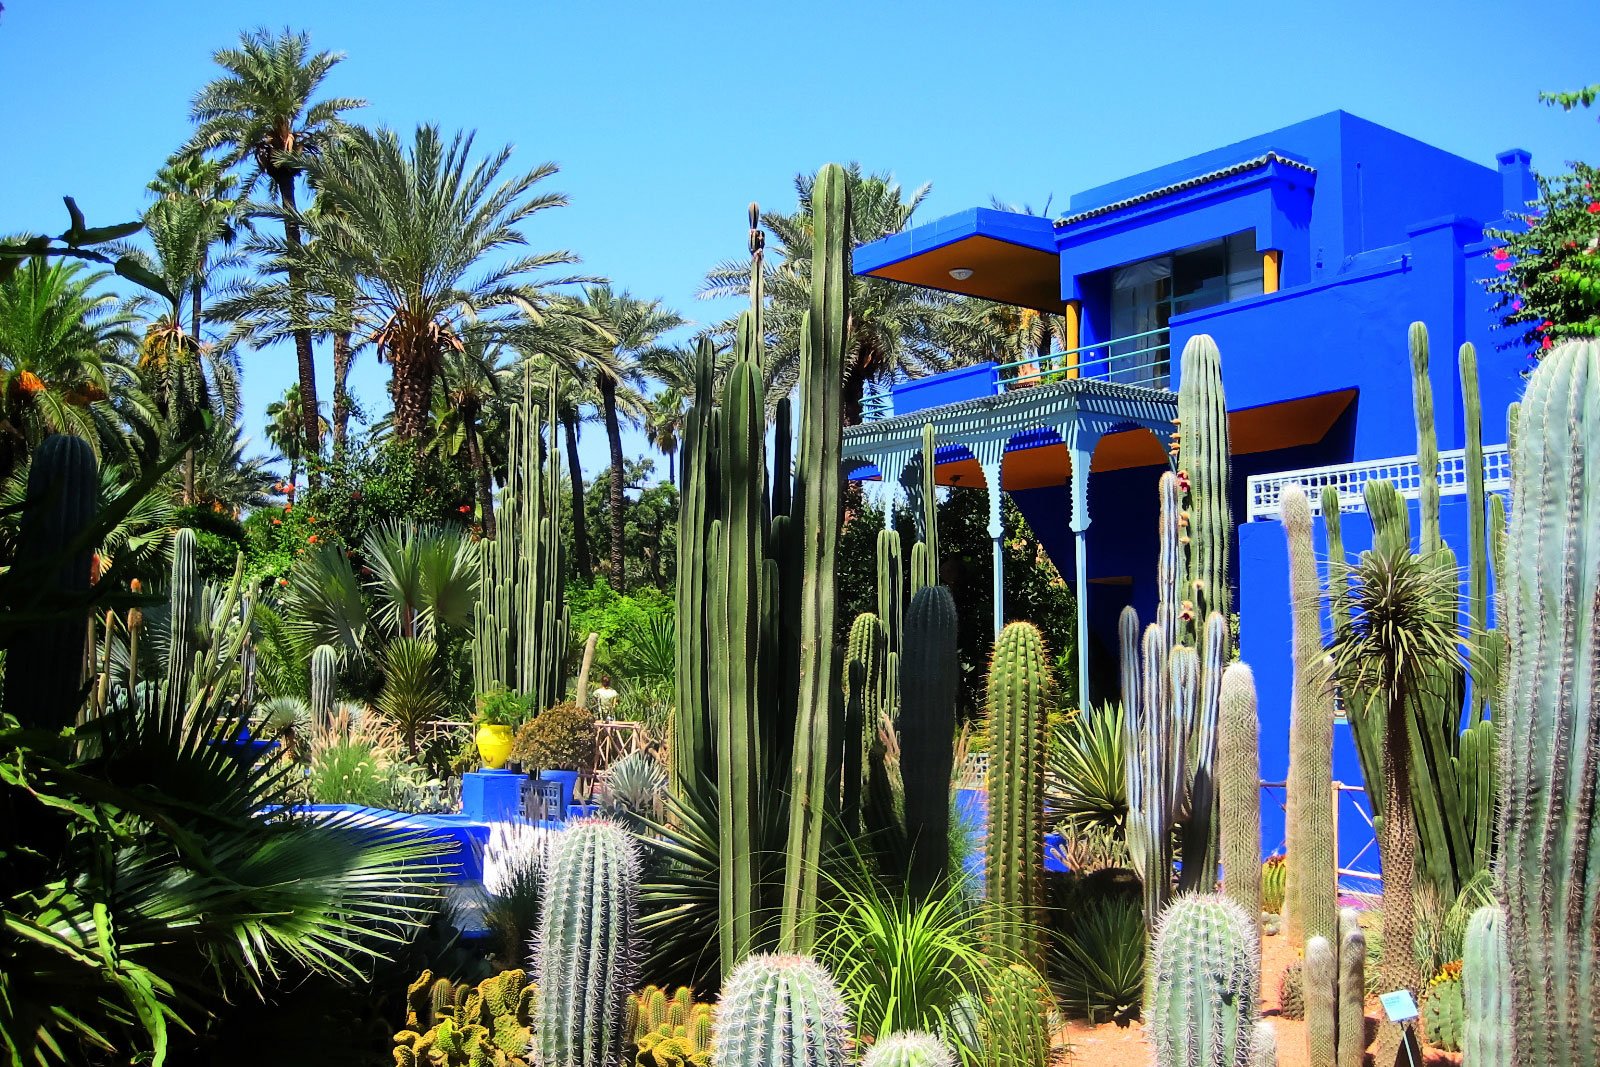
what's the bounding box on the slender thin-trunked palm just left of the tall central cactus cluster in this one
[569,285,685,592]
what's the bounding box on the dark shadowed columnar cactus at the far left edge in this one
[5,434,99,733]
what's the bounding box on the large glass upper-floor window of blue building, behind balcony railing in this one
[1090,230,1262,389]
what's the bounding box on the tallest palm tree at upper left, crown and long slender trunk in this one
[186,30,366,456]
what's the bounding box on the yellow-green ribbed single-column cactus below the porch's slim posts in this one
[984,622,1050,969]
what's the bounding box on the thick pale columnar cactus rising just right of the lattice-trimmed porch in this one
[1178,334,1234,640]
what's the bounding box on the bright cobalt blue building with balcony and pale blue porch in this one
[845,112,1536,877]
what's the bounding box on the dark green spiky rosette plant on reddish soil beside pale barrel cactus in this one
[1051,894,1144,1024]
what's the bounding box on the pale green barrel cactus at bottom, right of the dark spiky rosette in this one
[1149,894,1261,1067]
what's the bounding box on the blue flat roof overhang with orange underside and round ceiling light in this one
[854,208,1062,312]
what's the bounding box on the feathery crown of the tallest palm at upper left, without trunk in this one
[187,29,366,192]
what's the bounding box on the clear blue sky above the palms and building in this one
[0,0,1600,474]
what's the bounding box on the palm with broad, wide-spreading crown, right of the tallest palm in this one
[285,126,579,440]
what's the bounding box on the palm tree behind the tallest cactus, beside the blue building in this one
[701,163,978,426]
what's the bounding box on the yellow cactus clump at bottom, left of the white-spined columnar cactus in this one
[394,971,534,1067]
